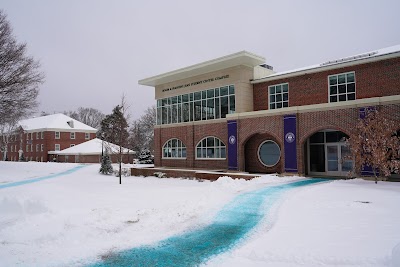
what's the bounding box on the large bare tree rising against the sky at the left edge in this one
[0,10,44,124]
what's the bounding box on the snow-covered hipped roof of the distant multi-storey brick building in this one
[19,113,97,132]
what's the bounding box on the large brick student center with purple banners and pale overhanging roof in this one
[139,46,400,176]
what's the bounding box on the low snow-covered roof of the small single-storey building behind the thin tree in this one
[49,138,136,155]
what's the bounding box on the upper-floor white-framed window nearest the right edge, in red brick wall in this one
[328,71,356,103]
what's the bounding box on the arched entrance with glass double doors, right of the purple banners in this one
[307,130,353,176]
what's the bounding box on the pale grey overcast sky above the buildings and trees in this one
[0,0,400,118]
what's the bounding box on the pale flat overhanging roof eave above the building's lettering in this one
[139,51,265,87]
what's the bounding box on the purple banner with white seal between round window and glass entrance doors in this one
[283,114,298,172]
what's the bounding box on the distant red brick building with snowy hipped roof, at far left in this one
[0,114,97,161]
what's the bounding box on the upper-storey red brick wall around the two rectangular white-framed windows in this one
[253,58,400,111]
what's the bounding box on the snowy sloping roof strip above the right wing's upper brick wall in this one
[253,45,400,83]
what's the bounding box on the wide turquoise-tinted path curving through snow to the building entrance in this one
[84,179,327,267]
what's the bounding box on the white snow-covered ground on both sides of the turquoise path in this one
[0,162,400,266]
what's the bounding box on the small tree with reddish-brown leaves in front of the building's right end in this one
[348,109,400,183]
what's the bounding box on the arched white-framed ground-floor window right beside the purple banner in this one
[196,136,226,159]
